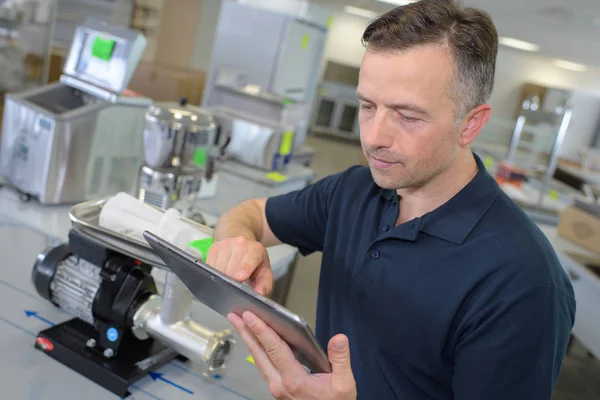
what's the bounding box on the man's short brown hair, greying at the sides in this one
[362,0,498,121]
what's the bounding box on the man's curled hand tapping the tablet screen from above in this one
[206,236,273,295]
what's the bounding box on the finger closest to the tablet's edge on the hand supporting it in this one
[242,311,307,382]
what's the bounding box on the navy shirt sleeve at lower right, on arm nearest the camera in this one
[453,282,575,400]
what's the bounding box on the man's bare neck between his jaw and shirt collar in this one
[396,150,478,225]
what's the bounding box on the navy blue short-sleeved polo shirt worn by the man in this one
[266,152,575,400]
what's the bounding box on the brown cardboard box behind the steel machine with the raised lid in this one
[129,62,206,105]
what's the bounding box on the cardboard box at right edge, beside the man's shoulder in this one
[558,206,600,254]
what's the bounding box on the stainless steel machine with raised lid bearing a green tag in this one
[0,20,152,204]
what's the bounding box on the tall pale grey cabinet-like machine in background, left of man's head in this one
[202,0,331,156]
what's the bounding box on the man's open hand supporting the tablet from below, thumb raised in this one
[227,311,356,400]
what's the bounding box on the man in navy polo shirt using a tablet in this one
[207,0,575,400]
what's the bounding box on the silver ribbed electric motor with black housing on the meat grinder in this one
[32,232,157,356]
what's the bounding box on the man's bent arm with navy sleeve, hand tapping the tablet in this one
[206,168,343,294]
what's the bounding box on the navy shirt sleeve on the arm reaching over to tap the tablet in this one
[265,167,348,255]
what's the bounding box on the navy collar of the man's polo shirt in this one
[381,154,501,244]
